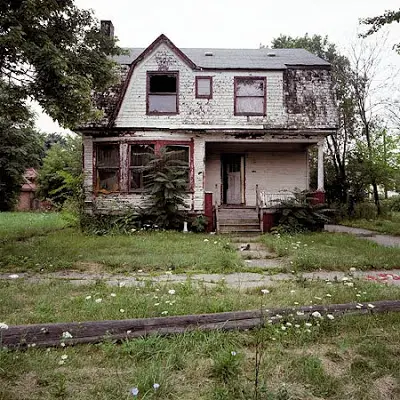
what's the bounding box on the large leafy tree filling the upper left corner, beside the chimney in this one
[0,0,121,128]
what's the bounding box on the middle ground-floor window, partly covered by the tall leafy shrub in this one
[129,144,154,191]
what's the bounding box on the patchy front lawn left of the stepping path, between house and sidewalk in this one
[0,228,243,272]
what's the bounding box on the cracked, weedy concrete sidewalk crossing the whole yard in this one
[0,269,400,289]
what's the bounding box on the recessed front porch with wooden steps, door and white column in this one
[204,142,324,233]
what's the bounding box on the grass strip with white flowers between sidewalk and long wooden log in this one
[0,280,400,325]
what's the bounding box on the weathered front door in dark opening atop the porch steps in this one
[222,154,244,205]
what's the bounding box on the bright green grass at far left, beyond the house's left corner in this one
[0,212,70,244]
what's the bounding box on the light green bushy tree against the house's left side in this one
[38,135,82,206]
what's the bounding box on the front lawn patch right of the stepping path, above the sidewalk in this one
[262,232,400,271]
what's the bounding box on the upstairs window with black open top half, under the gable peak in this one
[147,72,179,115]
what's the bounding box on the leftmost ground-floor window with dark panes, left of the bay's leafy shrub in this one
[96,144,119,193]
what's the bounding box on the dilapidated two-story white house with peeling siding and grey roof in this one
[80,21,338,232]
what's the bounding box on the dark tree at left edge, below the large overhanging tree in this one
[0,79,43,211]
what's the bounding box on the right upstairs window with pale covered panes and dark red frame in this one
[234,76,266,115]
